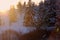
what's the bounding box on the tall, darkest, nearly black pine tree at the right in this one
[44,0,56,27]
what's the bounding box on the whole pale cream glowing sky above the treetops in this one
[0,0,43,11]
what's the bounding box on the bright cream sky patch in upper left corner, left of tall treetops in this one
[0,0,19,12]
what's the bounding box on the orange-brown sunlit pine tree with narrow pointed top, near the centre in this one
[24,0,34,26]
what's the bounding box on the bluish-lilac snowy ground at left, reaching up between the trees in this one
[0,12,35,34]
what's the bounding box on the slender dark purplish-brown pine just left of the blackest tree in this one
[35,1,44,29]
